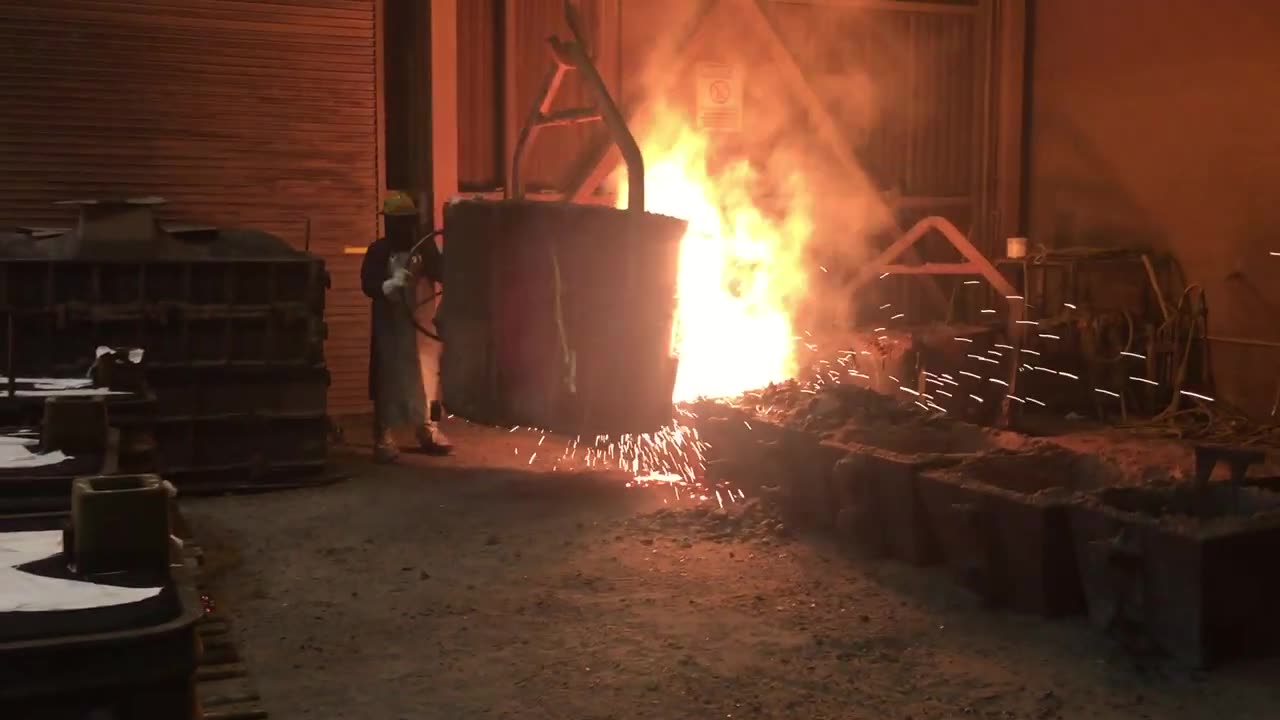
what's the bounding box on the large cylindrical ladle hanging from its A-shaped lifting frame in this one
[439,0,687,438]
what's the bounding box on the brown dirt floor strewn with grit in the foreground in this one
[183,425,1280,720]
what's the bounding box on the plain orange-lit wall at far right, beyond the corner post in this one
[1027,0,1280,415]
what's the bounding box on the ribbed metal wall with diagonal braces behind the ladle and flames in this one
[458,0,992,249]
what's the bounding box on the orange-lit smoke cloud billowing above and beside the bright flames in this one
[614,0,908,334]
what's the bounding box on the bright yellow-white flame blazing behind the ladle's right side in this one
[618,104,813,402]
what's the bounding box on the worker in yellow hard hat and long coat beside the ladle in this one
[360,192,452,462]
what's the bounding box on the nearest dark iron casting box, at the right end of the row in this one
[1071,483,1280,667]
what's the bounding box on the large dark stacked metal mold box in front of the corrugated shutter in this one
[0,200,329,489]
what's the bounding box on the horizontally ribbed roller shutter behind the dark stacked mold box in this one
[0,0,380,414]
